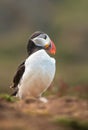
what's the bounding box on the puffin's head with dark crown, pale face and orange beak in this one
[27,31,55,55]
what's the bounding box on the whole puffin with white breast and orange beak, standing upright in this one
[10,31,56,102]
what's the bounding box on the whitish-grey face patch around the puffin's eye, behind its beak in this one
[32,34,51,47]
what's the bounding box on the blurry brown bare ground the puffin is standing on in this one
[0,96,88,130]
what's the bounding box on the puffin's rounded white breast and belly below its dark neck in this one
[18,49,55,98]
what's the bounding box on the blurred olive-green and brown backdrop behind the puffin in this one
[0,0,88,93]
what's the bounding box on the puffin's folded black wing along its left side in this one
[11,62,25,88]
